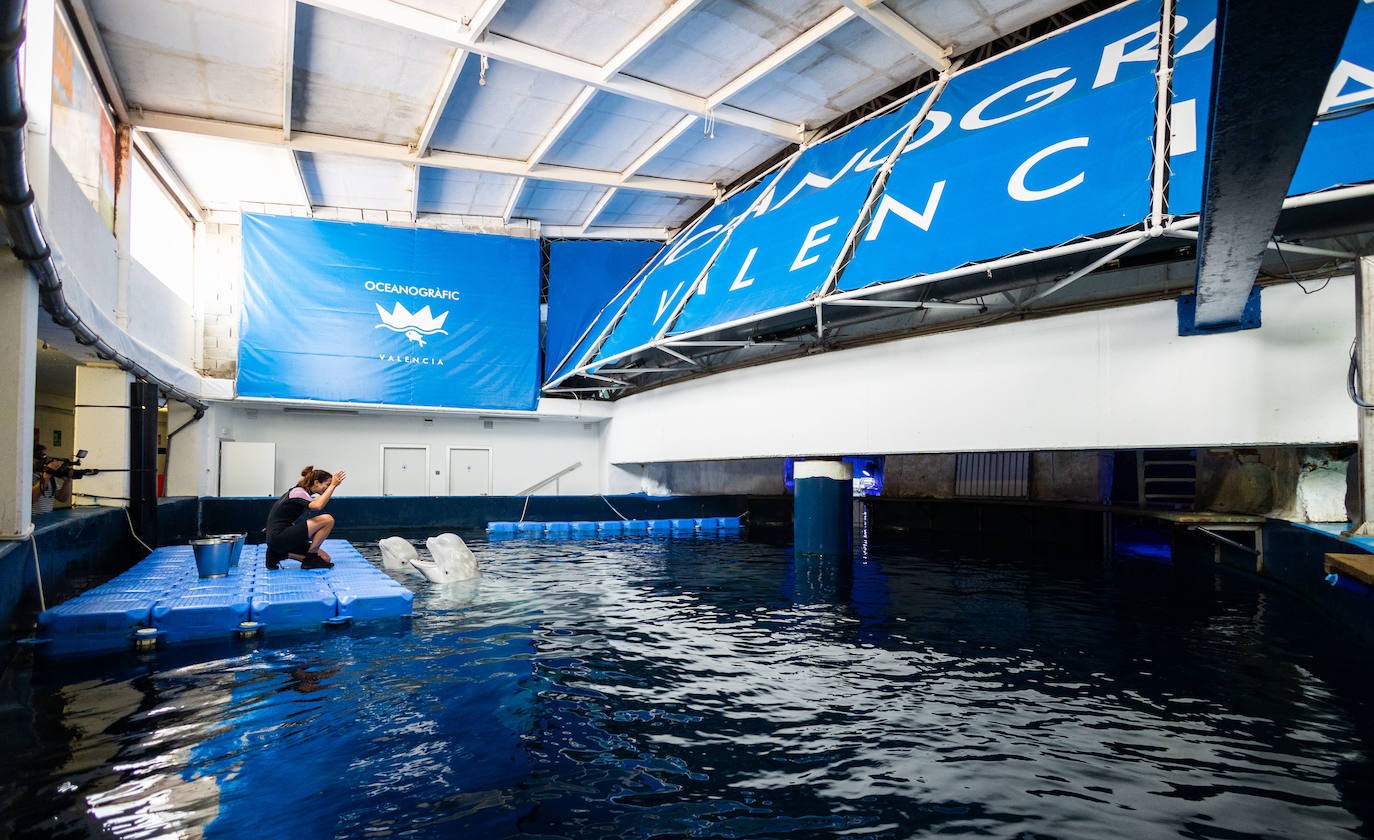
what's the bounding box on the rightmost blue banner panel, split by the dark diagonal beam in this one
[1169,0,1374,216]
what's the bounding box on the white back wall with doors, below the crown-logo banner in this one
[200,404,602,496]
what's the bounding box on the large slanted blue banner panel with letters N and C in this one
[840,0,1160,290]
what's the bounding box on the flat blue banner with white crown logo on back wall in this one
[238,214,539,410]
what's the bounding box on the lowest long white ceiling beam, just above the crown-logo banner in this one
[131,111,716,198]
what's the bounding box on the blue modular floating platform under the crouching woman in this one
[38,540,415,652]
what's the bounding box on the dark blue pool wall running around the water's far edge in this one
[8,495,1374,643]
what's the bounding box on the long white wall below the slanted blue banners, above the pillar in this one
[606,276,1356,464]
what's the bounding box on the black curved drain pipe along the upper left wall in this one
[0,0,206,419]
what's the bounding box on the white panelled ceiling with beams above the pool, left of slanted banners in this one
[73,0,1074,238]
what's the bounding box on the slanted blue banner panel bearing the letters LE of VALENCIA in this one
[672,92,929,333]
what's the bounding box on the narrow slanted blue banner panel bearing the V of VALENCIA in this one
[596,179,771,359]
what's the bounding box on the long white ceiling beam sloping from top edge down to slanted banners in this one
[301,0,801,143]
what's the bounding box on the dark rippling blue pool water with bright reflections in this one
[0,533,1374,840]
